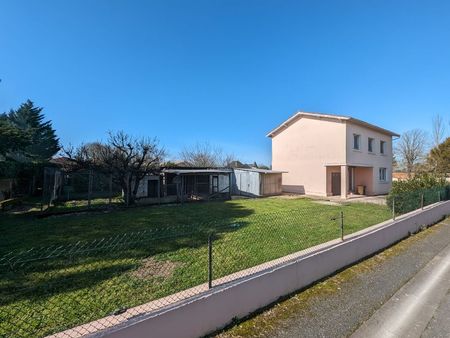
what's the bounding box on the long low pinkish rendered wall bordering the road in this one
[97,201,450,338]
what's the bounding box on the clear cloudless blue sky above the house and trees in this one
[0,0,450,164]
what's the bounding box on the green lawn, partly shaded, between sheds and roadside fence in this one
[0,198,390,337]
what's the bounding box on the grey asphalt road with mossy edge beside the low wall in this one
[219,219,450,338]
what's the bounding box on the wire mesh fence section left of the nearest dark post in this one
[0,227,212,337]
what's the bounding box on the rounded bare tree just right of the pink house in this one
[396,129,427,176]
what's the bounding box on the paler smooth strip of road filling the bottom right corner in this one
[352,240,450,338]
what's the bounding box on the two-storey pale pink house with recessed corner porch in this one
[267,112,399,198]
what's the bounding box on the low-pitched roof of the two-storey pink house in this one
[267,112,400,137]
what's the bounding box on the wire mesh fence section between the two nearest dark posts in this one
[209,209,341,286]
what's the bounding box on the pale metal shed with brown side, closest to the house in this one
[233,168,283,197]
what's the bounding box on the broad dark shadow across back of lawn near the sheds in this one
[0,202,253,252]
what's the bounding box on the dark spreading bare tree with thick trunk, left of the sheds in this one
[64,131,165,204]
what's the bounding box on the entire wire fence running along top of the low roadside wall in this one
[0,193,448,337]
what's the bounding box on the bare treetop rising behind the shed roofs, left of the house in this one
[180,142,235,167]
